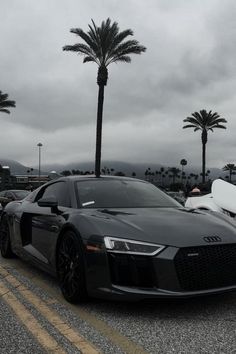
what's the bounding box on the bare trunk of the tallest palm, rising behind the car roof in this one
[95,85,104,177]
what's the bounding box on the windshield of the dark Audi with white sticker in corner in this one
[76,178,181,208]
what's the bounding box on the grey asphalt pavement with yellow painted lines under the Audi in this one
[0,254,236,354]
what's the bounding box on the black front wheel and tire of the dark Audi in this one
[57,231,88,303]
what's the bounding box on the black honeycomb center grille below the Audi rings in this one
[174,244,236,291]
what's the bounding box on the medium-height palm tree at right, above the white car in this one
[183,109,227,183]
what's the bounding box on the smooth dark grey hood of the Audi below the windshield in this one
[86,208,236,247]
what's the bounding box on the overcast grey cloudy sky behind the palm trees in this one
[0,0,236,168]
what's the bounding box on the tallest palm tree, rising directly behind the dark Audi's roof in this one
[63,18,146,177]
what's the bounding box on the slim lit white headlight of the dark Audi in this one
[104,236,165,256]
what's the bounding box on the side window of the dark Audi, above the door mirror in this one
[36,181,70,207]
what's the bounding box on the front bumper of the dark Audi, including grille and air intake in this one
[88,244,236,300]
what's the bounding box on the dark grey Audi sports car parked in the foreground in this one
[0,176,236,302]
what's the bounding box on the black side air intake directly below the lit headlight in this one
[108,253,157,288]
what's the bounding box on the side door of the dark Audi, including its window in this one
[21,181,70,264]
